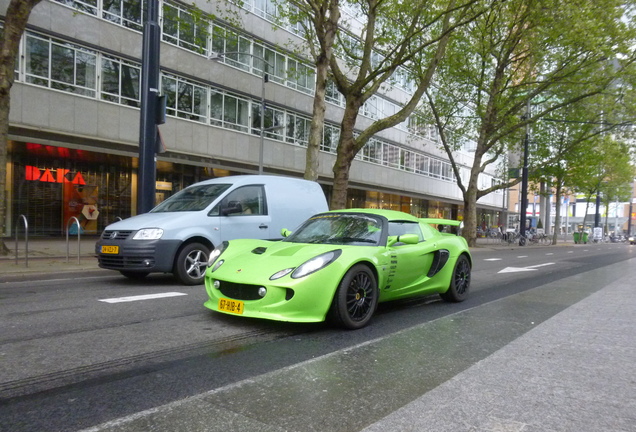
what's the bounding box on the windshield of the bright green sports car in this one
[284,213,382,246]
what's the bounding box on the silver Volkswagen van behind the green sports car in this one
[95,175,328,285]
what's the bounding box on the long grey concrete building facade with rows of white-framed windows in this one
[0,0,507,235]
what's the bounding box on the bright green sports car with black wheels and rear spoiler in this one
[205,209,472,329]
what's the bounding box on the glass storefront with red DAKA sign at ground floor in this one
[8,142,221,235]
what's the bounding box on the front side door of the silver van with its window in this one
[213,185,271,240]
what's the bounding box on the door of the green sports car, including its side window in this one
[389,221,433,296]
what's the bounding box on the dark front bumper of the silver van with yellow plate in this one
[95,239,181,273]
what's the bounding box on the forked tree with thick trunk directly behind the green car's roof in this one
[330,0,490,209]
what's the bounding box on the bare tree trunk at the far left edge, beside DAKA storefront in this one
[0,0,41,255]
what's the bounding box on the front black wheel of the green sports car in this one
[330,264,378,330]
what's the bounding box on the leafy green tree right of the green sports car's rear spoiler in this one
[427,0,635,246]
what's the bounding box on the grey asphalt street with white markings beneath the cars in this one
[0,238,636,431]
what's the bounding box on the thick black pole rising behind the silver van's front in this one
[137,0,161,214]
